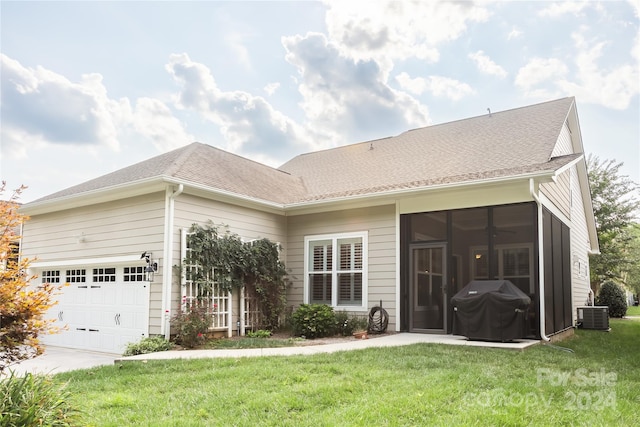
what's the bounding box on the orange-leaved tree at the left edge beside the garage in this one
[0,182,61,372]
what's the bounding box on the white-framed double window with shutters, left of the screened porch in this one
[304,232,367,308]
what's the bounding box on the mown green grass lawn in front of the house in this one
[55,320,640,426]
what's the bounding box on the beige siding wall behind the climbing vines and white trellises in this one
[171,194,286,331]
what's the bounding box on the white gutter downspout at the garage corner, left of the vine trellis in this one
[160,184,184,339]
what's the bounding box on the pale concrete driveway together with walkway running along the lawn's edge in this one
[10,333,539,375]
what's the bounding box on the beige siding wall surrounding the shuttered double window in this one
[286,205,396,330]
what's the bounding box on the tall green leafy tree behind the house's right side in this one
[587,155,639,289]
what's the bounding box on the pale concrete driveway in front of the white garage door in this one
[9,346,121,375]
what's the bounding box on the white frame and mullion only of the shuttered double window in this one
[303,231,369,311]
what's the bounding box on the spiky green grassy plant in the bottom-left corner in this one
[0,371,80,427]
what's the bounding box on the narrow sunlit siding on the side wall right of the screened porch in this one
[570,167,591,321]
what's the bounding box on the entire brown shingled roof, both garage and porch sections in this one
[28,98,580,211]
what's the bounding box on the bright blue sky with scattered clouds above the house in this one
[0,0,640,202]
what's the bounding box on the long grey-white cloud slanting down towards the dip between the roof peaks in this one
[166,54,306,165]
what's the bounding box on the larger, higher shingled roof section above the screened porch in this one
[280,98,579,200]
